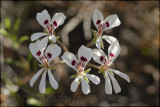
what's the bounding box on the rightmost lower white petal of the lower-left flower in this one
[48,69,58,89]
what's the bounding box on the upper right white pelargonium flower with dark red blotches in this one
[93,9,121,49]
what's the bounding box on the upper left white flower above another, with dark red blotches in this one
[31,10,66,44]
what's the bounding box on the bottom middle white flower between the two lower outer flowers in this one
[61,45,100,94]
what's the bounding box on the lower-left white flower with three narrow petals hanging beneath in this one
[29,40,61,93]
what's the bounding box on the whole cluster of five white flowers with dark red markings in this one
[29,9,130,94]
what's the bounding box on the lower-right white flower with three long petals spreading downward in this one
[93,39,130,94]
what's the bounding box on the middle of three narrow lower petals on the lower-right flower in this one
[108,72,121,93]
